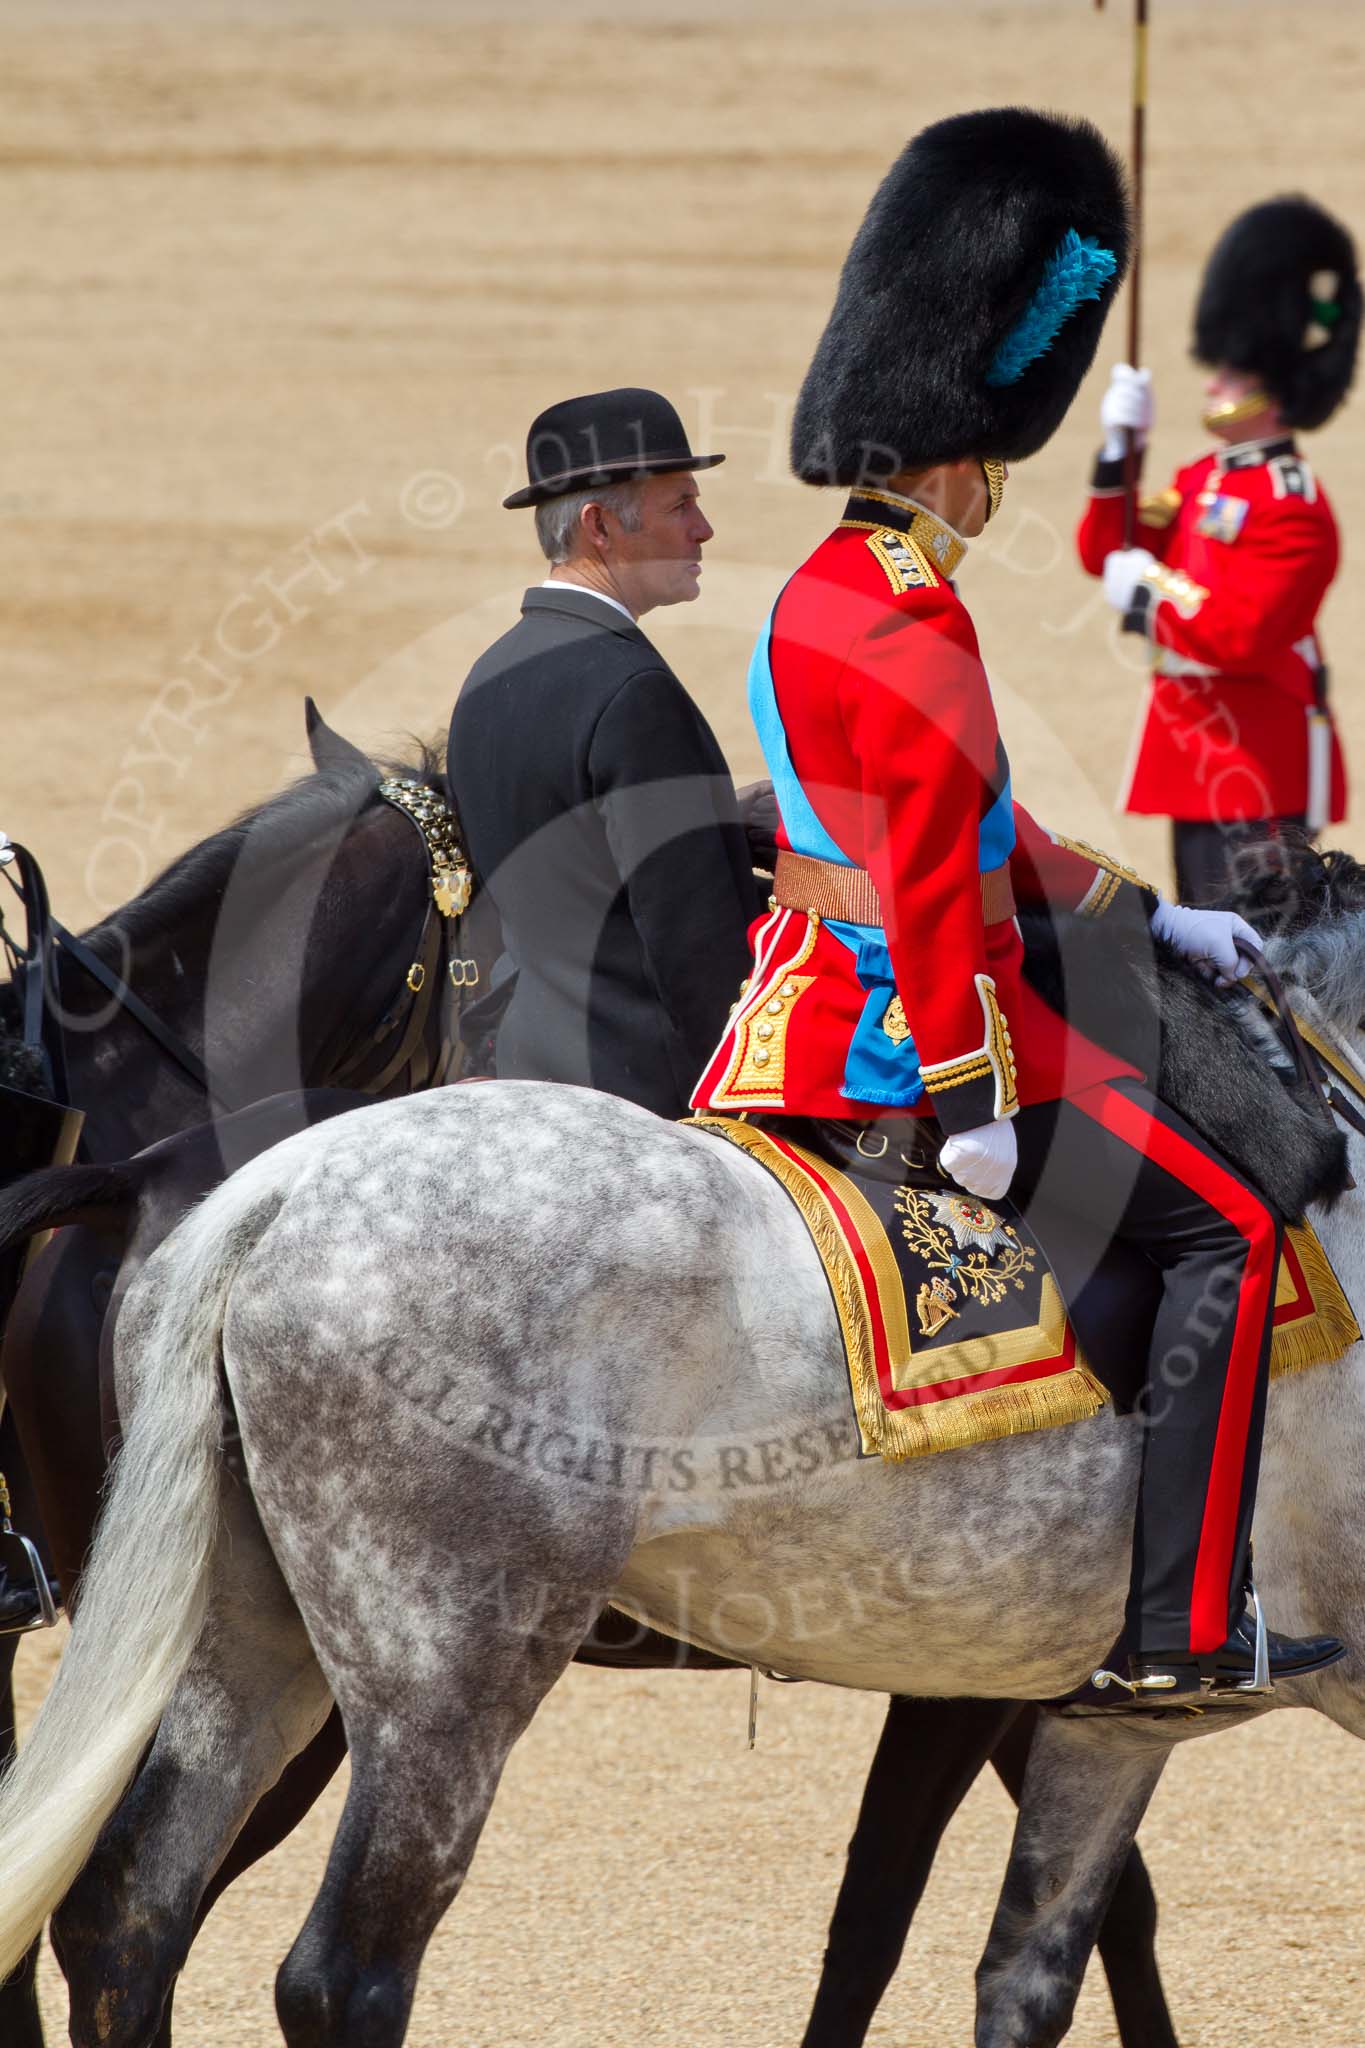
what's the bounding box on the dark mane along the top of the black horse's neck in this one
[0,739,446,1092]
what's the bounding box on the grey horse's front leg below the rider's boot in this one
[976,1714,1177,2048]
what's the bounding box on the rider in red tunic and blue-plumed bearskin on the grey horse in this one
[694,109,1340,1702]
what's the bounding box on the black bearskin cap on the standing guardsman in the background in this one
[1195,197,1361,426]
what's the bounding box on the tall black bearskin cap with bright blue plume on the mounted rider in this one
[792,106,1132,485]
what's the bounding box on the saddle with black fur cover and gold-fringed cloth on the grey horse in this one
[694,926,1361,1460]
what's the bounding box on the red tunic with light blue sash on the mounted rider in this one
[694,492,1140,1130]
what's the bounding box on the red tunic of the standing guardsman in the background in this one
[1076,436,1347,825]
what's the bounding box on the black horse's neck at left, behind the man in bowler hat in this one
[14,762,448,1159]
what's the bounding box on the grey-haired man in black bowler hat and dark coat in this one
[448,389,757,1116]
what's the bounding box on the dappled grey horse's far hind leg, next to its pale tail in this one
[53,1483,329,2048]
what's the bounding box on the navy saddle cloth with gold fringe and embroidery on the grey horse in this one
[694,1116,1361,1462]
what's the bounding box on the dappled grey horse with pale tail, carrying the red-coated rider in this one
[0,915,1365,2048]
